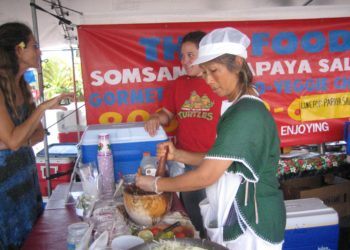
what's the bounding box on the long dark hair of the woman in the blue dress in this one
[0,22,34,118]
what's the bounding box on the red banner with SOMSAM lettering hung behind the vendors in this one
[78,18,350,146]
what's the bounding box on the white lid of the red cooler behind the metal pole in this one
[36,143,78,158]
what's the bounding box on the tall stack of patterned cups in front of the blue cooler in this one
[97,133,115,195]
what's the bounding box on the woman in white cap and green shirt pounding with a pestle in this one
[136,27,286,250]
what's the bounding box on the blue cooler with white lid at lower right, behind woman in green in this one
[283,198,339,250]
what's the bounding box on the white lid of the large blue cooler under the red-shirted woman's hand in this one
[81,122,168,145]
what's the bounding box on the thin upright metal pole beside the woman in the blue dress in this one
[30,0,51,197]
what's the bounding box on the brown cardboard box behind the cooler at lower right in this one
[281,176,350,217]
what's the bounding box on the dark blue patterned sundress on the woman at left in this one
[0,105,43,250]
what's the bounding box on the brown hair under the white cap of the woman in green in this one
[211,54,254,96]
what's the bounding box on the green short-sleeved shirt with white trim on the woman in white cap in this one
[205,95,286,243]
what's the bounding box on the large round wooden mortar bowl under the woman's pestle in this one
[124,189,172,226]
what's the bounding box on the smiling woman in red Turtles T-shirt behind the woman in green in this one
[145,31,223,236]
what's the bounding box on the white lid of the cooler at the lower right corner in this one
[284,198,338,230]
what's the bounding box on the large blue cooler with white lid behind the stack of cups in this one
[80,122,168,181]
